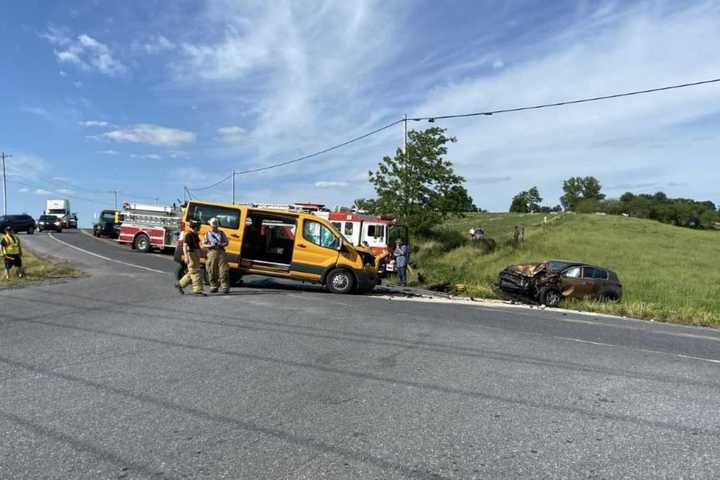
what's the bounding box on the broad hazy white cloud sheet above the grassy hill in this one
[415,2,720,210]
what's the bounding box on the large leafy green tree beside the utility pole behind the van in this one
[368,127,474,233]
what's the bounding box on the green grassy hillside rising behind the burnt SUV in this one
[414,213,720,326]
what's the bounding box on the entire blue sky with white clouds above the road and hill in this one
[0,0,720,225]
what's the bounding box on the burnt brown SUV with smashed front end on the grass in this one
[496,260,622,307]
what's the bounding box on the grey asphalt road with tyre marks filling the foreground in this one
[0,232,720,479]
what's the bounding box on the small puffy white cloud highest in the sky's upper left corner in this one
[43,27,127,76]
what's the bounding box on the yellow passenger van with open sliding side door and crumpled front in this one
[175,200,378,293]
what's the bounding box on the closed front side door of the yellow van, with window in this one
[290,216,342,281]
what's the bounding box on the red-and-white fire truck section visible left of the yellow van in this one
[117,202,182,253]
